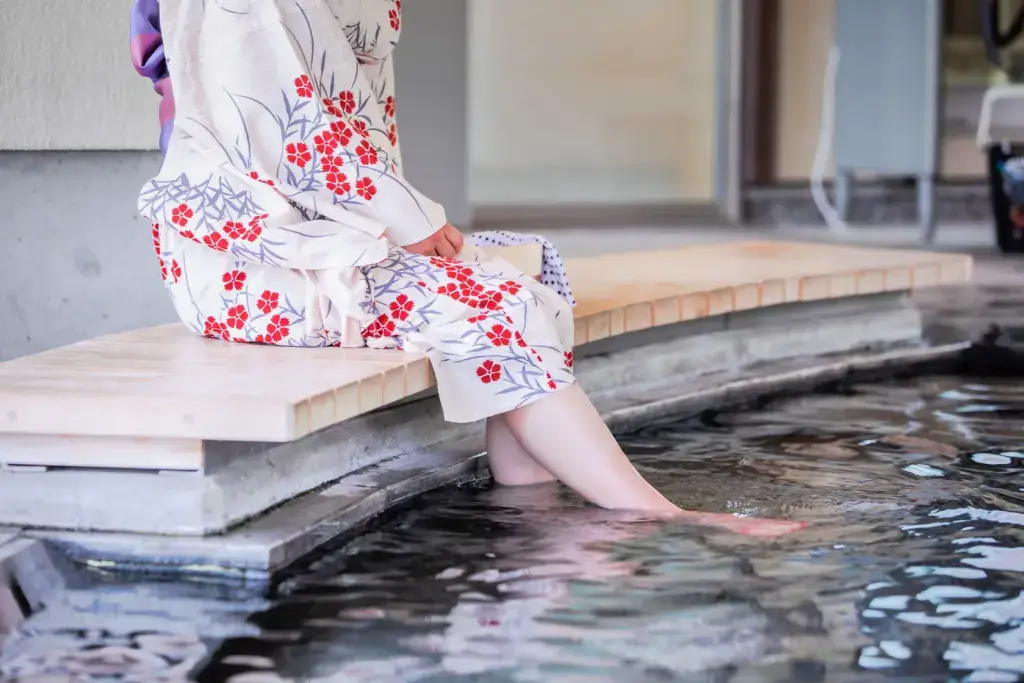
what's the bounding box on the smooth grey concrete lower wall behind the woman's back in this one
[0,152,174,360]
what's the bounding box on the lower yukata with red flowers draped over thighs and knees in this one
[364,250,574,417]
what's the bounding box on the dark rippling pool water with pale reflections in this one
[0,378,1024,683]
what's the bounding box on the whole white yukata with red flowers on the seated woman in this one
[131,0,574,422]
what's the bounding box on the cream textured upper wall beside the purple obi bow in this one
[0,0,160,150]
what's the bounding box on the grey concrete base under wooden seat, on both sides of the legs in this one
[0,294,921,536]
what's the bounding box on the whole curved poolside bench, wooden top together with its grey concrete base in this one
[0,237,971,577]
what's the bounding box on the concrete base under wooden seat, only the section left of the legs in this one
[0,399,482,536]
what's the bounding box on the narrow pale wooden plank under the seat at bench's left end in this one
[0,434,204,471]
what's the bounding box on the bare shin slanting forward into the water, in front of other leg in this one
[504,385,680,513]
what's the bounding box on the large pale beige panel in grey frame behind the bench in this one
[470,0,717,203]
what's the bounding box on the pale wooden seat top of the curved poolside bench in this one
[0,242,972,471]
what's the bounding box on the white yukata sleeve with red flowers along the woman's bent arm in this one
[175,0,446,246]
